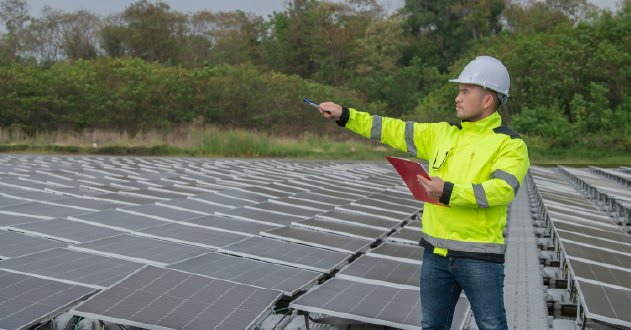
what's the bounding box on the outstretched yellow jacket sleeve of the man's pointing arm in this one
[338,108,435,159]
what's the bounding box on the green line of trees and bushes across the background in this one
[0,0,631,151]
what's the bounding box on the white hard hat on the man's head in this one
[449,56,510,104]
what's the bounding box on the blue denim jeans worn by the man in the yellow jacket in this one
[421,249,508,330]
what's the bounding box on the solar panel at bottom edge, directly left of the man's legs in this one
[289,278,432,330]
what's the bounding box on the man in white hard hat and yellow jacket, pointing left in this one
[320,56,530,330]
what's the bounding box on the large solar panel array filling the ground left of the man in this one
[0,155,440,329]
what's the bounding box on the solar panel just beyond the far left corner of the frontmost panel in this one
[68,234,208,267]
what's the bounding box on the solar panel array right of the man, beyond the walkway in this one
[530,166,631,327]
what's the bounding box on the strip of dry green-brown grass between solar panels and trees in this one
[0,127,631,165]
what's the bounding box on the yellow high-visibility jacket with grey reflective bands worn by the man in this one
[338,108,530,263]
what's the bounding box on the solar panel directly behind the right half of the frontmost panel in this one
[165,252,322,296]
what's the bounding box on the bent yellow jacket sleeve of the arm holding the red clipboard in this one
[440,139,530,208]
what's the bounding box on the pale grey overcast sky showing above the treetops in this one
[21,0,618,17]
